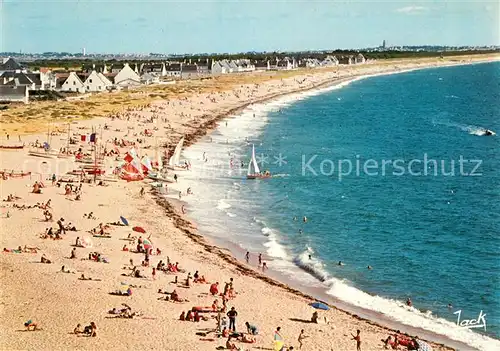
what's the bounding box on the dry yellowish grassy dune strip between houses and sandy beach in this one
[0,55,493,135]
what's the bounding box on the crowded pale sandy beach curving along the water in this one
[0,56,498,350]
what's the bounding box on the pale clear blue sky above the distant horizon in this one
[0,0,500,54]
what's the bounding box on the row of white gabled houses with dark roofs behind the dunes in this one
[0,54,366,101]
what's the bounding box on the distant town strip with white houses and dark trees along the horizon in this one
[0,40,500,104]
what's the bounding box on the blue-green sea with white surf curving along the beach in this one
[183,63,500,350]
